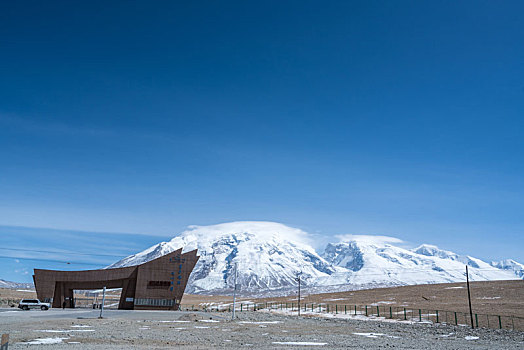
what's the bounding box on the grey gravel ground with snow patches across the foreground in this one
[0,309,524,349]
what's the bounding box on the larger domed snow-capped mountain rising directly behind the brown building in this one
[110,221,337,293]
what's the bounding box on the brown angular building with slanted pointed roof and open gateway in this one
[33,248,199,310]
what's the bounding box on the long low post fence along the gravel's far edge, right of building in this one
[182,303,524,331]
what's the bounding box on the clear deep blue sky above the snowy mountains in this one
[0,1,524,280]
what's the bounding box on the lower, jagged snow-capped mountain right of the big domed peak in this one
[322,236,517,285]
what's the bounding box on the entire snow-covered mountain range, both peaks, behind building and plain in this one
[109,221,524,295]
